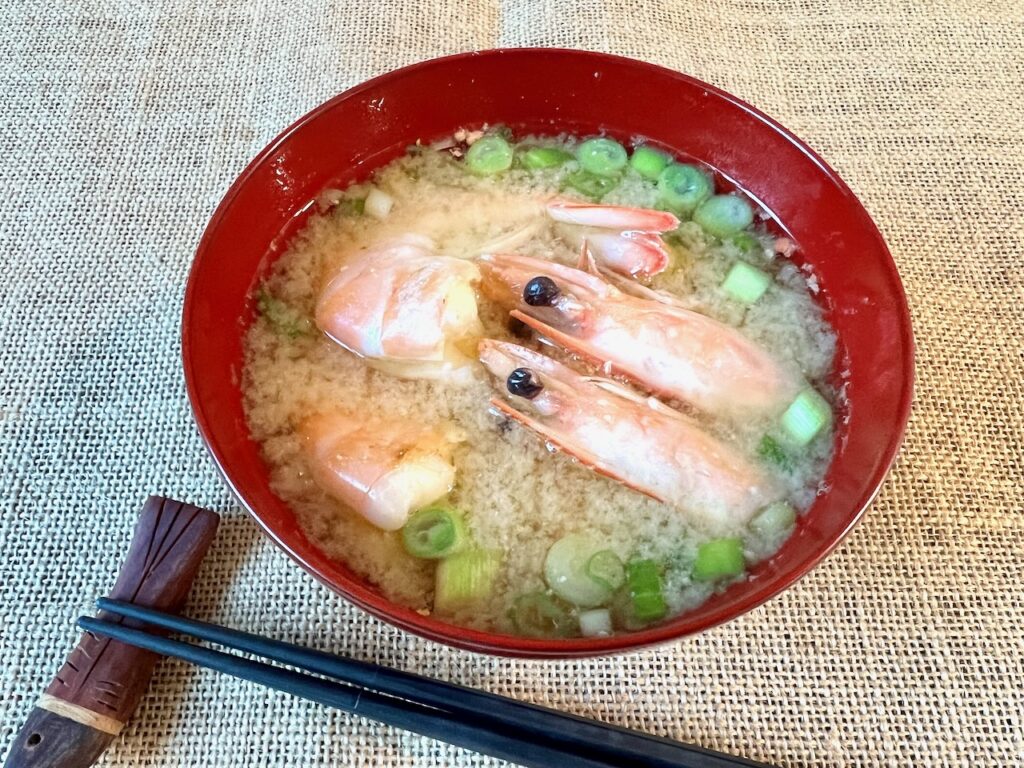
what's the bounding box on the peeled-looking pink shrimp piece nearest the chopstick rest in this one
[299,413,455,530]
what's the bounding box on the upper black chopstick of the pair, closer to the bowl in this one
[97,598,764,768]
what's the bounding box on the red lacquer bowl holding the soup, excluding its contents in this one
[182,49,913,657]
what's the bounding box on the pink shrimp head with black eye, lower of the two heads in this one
[480,339,783,532]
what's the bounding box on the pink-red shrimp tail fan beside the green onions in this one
[547,200,679,278]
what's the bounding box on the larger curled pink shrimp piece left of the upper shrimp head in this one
[315,234,482,383]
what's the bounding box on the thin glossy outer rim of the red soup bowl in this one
[181,47,916,658]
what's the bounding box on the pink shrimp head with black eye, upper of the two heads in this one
[480,254,802,419]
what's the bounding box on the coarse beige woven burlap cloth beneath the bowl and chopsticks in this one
[0,0,1024,768]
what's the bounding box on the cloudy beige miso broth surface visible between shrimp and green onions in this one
[243,139,835,631]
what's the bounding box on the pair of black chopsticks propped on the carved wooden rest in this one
[78,598,765,768]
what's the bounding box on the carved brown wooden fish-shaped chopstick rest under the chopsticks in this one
[4,496,220,768]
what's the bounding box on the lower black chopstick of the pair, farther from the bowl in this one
[78,616,621,768]
